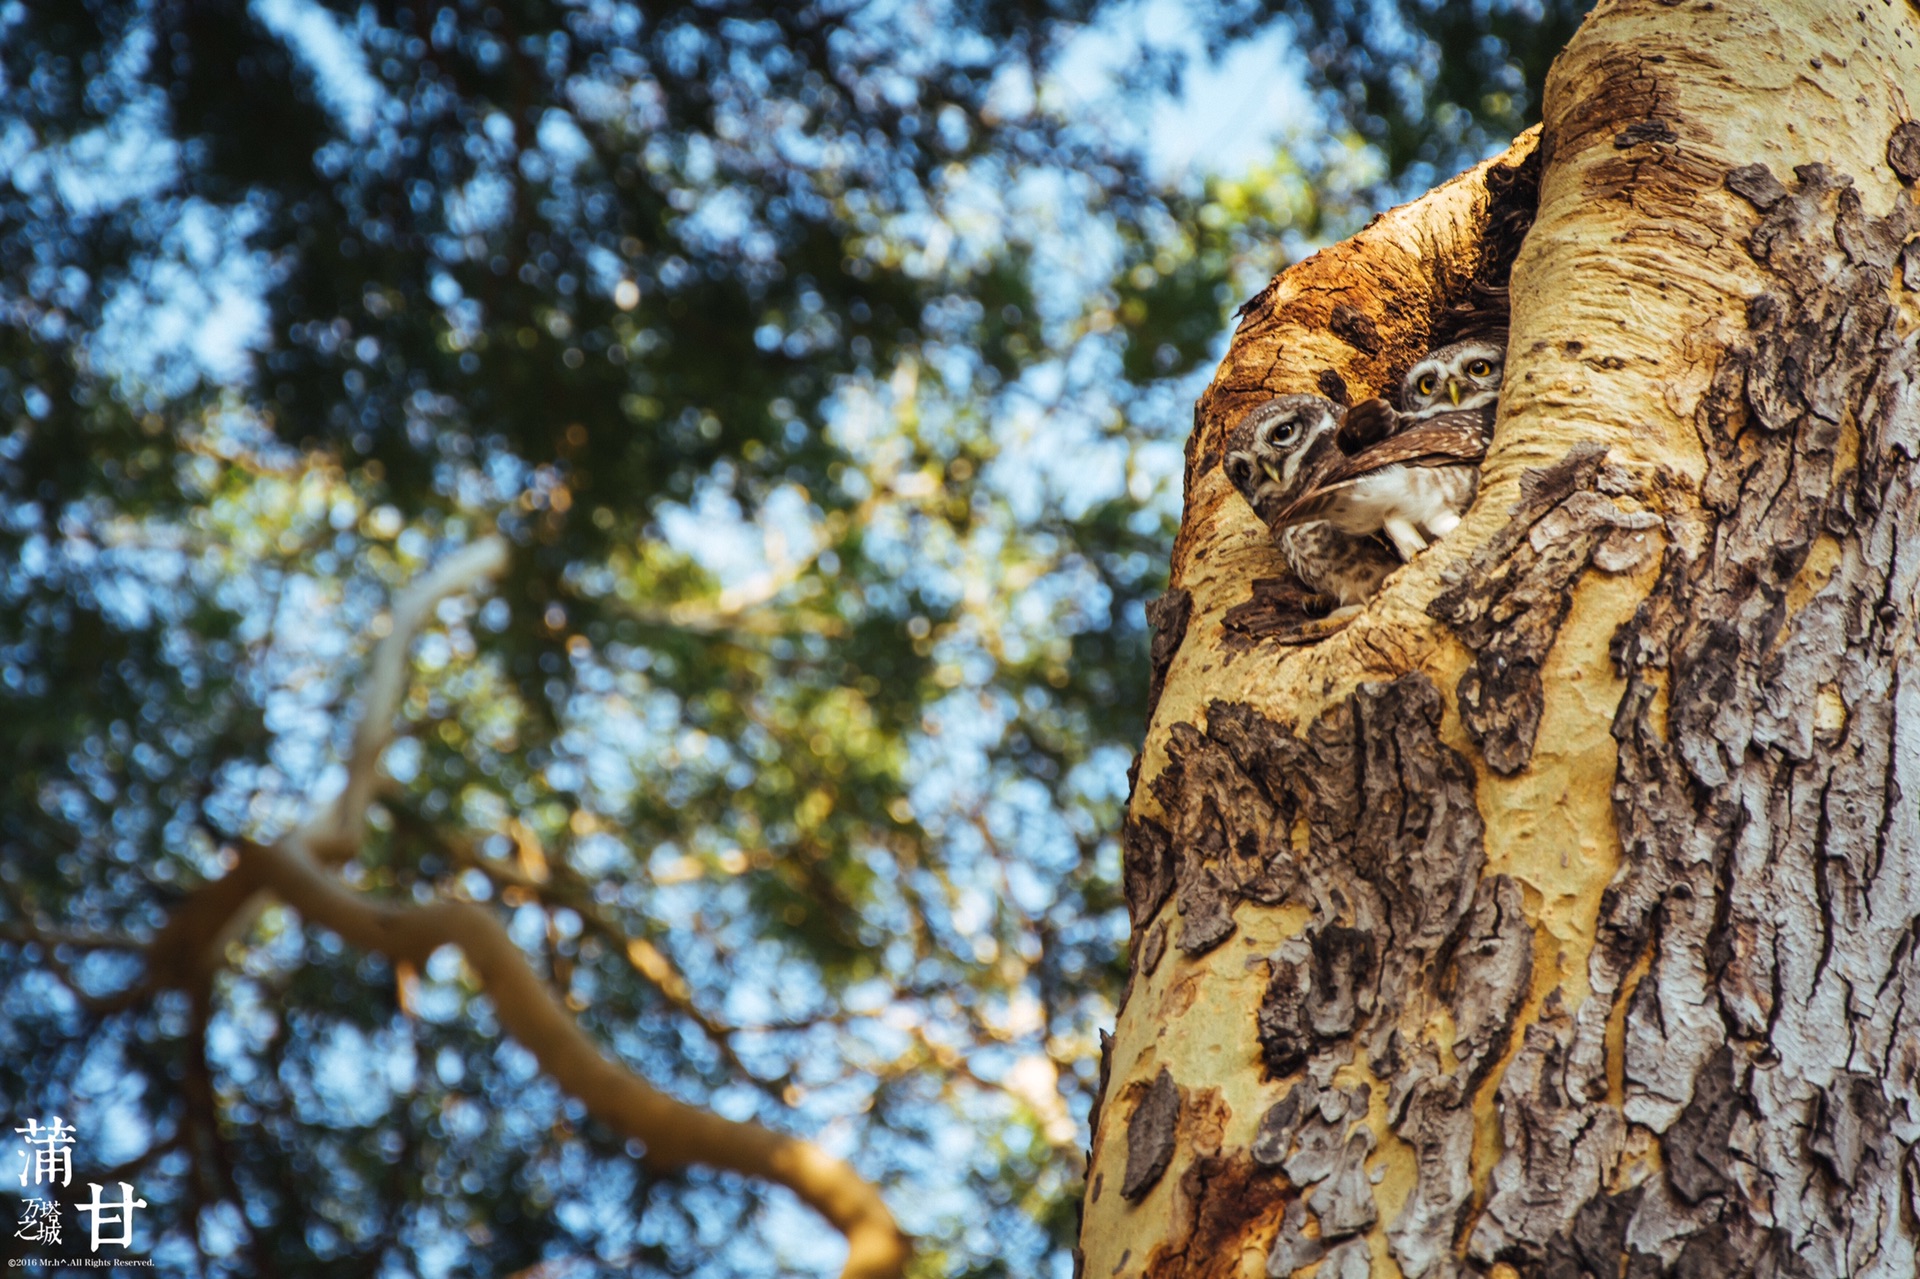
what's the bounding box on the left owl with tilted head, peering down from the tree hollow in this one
[1221,396,1400,618]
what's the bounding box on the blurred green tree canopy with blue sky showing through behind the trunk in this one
[0,0,1584,1275]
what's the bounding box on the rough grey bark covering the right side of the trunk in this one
[1473,156,1920,1279]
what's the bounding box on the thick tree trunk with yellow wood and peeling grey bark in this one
[1081,0,1920,1279]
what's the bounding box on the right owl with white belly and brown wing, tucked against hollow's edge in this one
[1275,342,1505,559]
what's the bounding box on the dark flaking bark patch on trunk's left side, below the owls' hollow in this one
[1121,676,1532,1273]
